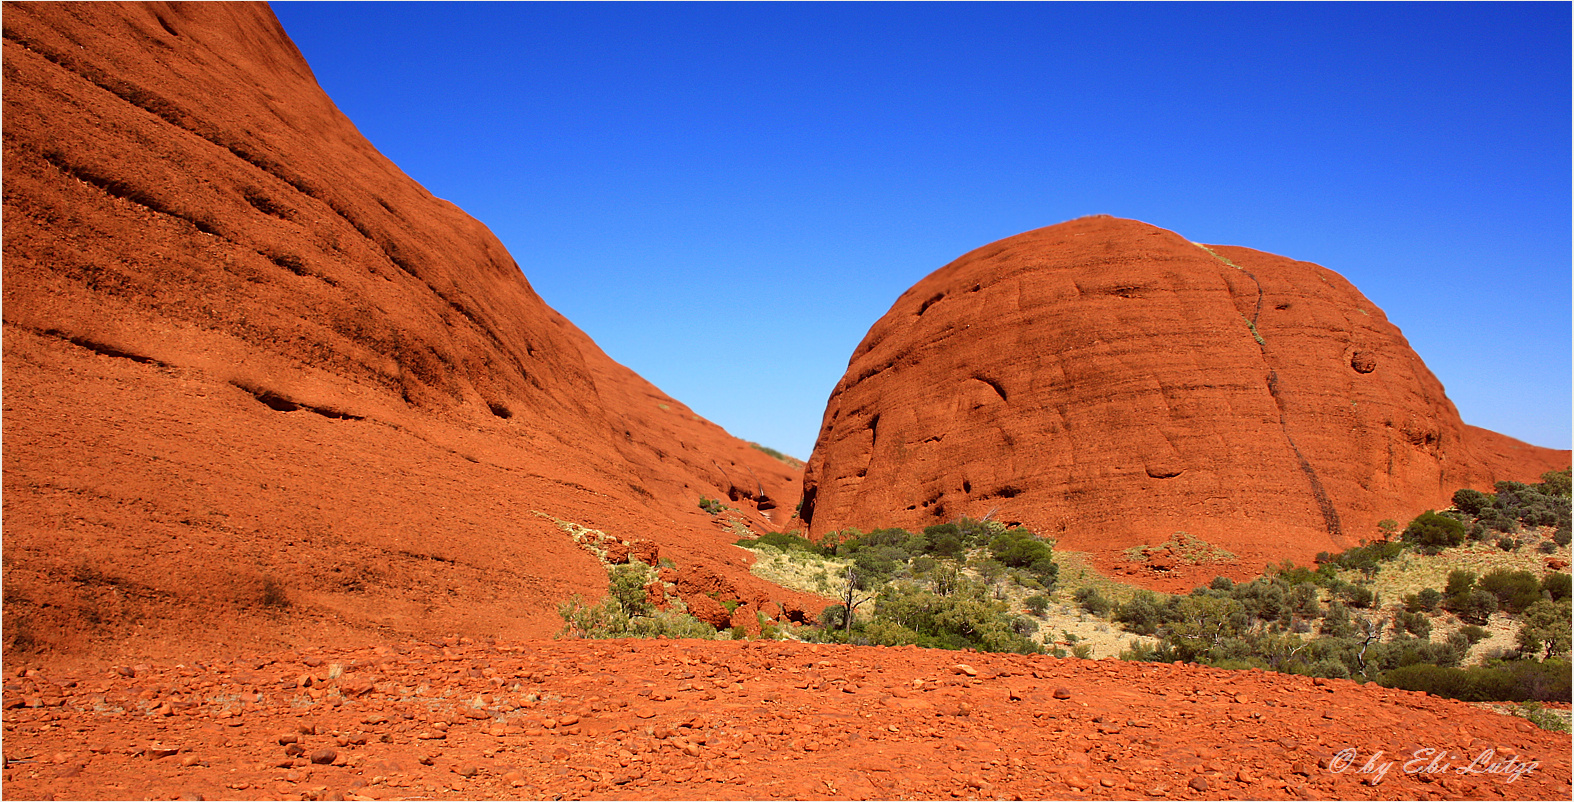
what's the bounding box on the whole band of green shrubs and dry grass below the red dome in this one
[560,470,1574,713]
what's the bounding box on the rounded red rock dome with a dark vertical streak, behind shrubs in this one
[803,217,1569,580]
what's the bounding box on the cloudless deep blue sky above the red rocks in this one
[274,3,1574,458]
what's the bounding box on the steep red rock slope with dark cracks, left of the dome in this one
[3,3,815,659]
